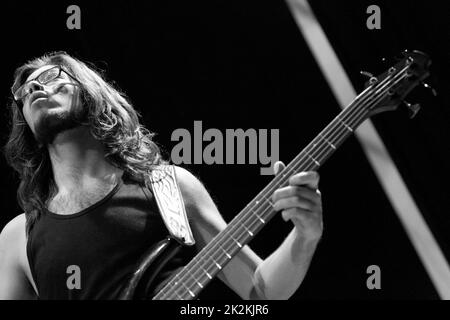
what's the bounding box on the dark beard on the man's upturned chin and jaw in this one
[35,101,87,145]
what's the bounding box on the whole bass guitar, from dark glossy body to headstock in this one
[121,51,431,300]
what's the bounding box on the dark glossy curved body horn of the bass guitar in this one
[119,237,182,300]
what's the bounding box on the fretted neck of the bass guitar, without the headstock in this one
[153,92,367,300]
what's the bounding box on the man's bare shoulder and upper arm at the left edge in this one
[0,214,36,300]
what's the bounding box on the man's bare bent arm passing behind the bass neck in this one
[176,167,318,299]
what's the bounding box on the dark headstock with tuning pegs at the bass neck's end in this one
[363,50,431,116]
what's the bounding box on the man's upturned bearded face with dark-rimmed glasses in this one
[22,65,83,144]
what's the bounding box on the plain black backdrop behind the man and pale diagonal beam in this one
[0,0,450,299]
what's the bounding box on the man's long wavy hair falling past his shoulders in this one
[4,51,167,235]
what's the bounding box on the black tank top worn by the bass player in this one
[27,175,194,300]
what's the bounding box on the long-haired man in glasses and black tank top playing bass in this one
[0,52,322,299]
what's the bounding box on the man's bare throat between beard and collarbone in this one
[48,126,123,194]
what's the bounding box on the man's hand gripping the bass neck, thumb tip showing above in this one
[272,161,323,240]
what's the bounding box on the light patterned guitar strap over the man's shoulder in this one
[146,165,195,246]
